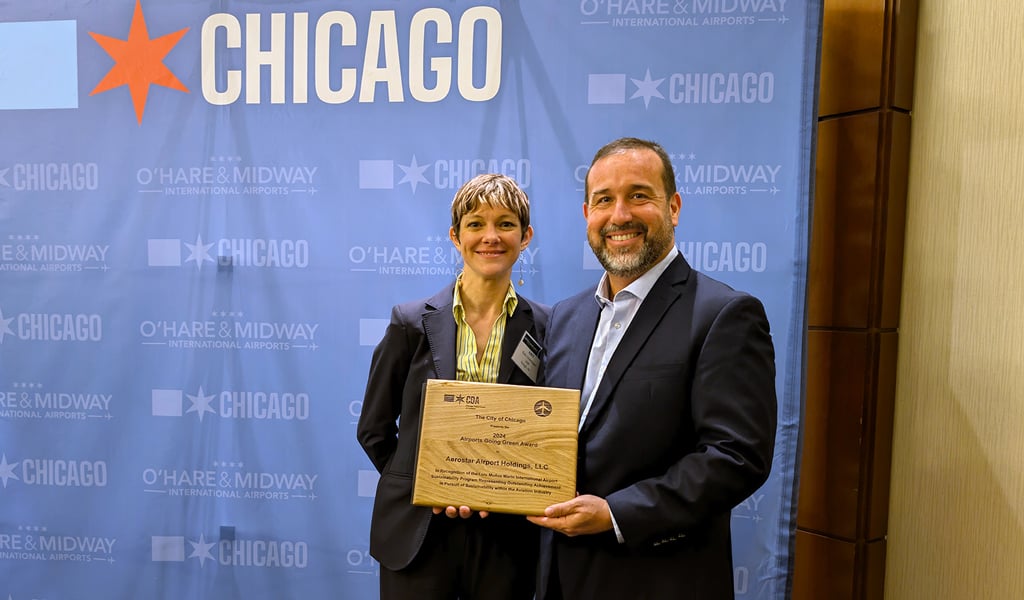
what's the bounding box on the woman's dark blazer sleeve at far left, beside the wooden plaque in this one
[356,306,413,473]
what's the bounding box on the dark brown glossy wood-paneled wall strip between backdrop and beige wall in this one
[793,0,918,600]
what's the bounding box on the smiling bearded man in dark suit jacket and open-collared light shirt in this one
[527,138,776,600]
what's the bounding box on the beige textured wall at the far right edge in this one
[885,0,1024,600]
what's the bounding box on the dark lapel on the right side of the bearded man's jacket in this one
[581,255,690,433]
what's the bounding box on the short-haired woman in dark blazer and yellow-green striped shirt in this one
[357,174,549,600]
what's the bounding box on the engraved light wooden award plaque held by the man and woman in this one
[413,379,580,515]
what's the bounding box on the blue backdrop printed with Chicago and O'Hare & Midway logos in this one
[0,0,821,600]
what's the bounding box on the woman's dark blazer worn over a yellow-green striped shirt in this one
[356,283,549,570]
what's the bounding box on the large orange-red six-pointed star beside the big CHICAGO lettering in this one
[89,0,188,125]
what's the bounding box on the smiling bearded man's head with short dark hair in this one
[583,148,682,292]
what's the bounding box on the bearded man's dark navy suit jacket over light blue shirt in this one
[537,256,776,600]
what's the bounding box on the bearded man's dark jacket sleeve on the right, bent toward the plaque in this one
[607,295,777,546]
